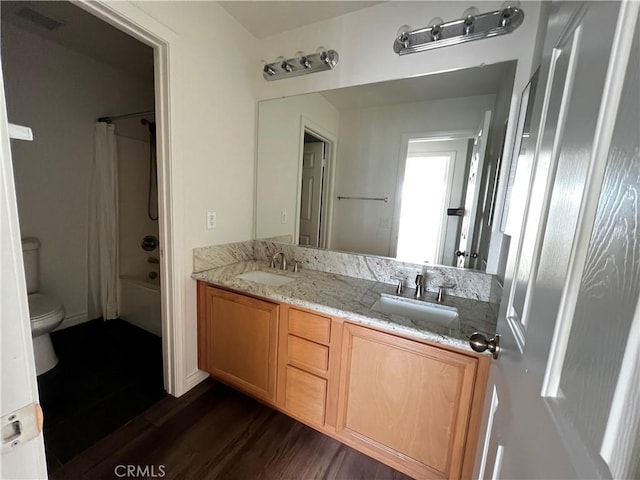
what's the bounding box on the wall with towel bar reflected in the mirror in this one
[331,95,495,256]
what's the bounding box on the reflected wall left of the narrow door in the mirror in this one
[255,94,339,243]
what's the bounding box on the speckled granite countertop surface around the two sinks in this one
[191,260,499,351]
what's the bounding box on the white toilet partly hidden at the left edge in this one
[22,238,65,375]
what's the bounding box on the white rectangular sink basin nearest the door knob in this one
[371,293,459,328]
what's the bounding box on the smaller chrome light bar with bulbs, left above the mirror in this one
[262,47,339,82]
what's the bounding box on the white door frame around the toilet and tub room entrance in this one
[74,0,185,396]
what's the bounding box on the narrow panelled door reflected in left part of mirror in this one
[298,142,325,247]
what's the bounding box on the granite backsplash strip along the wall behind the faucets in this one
[193,240,502,304]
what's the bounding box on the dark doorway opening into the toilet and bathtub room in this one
[2,2,172,469]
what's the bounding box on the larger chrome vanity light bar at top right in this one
[393,6,524,55]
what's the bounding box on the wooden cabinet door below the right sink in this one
[337,323,477,478]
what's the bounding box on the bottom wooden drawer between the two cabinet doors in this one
[285,365,327,425]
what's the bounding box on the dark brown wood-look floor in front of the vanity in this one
[50,380,409,480]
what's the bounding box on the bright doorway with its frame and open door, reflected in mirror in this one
[391,110,496,268]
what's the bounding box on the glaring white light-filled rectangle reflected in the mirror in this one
[396,147,455,264]
